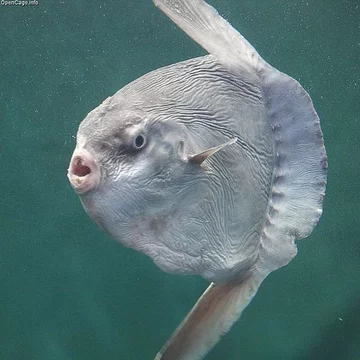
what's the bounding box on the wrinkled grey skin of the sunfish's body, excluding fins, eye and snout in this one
[69,56,274,282]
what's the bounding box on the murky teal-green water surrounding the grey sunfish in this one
[0,0,360,360]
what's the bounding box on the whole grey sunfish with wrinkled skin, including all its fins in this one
[68,0,327,360]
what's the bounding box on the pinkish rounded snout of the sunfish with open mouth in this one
[67,149,101,194]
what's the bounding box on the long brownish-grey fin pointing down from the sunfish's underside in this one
[155,275,263,360]
